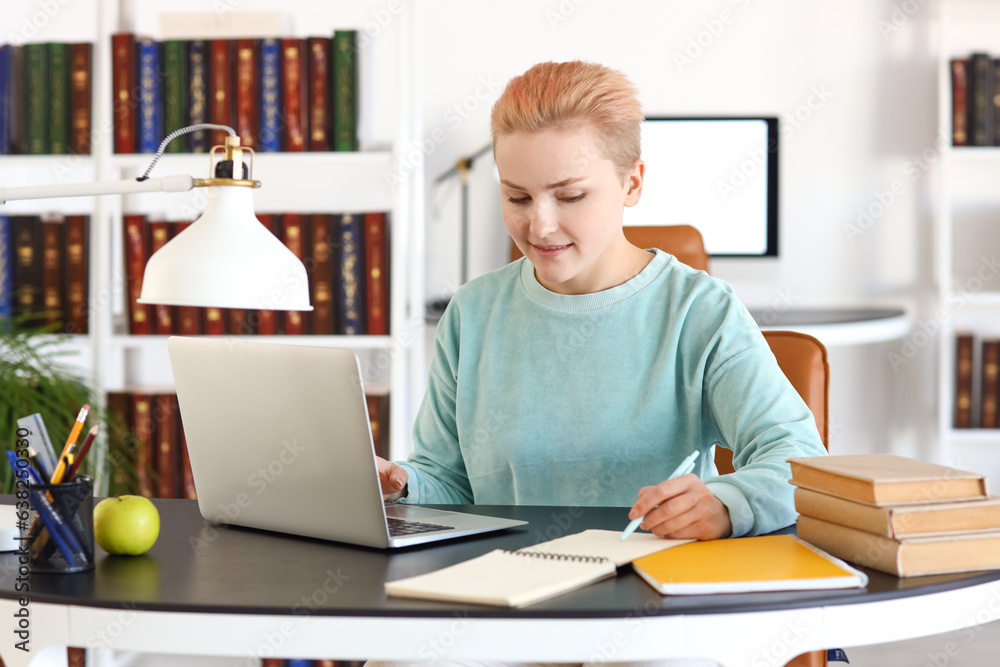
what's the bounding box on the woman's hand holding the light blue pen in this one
[628,475,733,540]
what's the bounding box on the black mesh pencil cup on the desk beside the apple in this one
[22,475,94,574]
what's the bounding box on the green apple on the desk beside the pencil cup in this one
[94,495,160,556]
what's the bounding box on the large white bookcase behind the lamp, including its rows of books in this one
[0,0,424,496]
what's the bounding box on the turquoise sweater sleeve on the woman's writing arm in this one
[704,300,826,537]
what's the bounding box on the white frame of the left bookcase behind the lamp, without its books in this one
[0,0,425,489]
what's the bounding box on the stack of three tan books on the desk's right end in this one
[789,454,1000,577]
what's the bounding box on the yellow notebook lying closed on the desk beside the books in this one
[632,535,868,595]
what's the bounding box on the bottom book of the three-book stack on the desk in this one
[797,516,1000,577]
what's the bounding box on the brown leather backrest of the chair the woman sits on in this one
[715,331,830,474]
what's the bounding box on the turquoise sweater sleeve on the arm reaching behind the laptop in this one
[396,300,475,504]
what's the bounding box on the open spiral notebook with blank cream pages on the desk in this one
[385,530,690,607]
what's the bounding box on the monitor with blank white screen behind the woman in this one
[625,116,778,257]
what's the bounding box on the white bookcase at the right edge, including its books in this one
[932,0,1000,477]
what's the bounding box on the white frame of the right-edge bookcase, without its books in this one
[932,0,1000,478]
